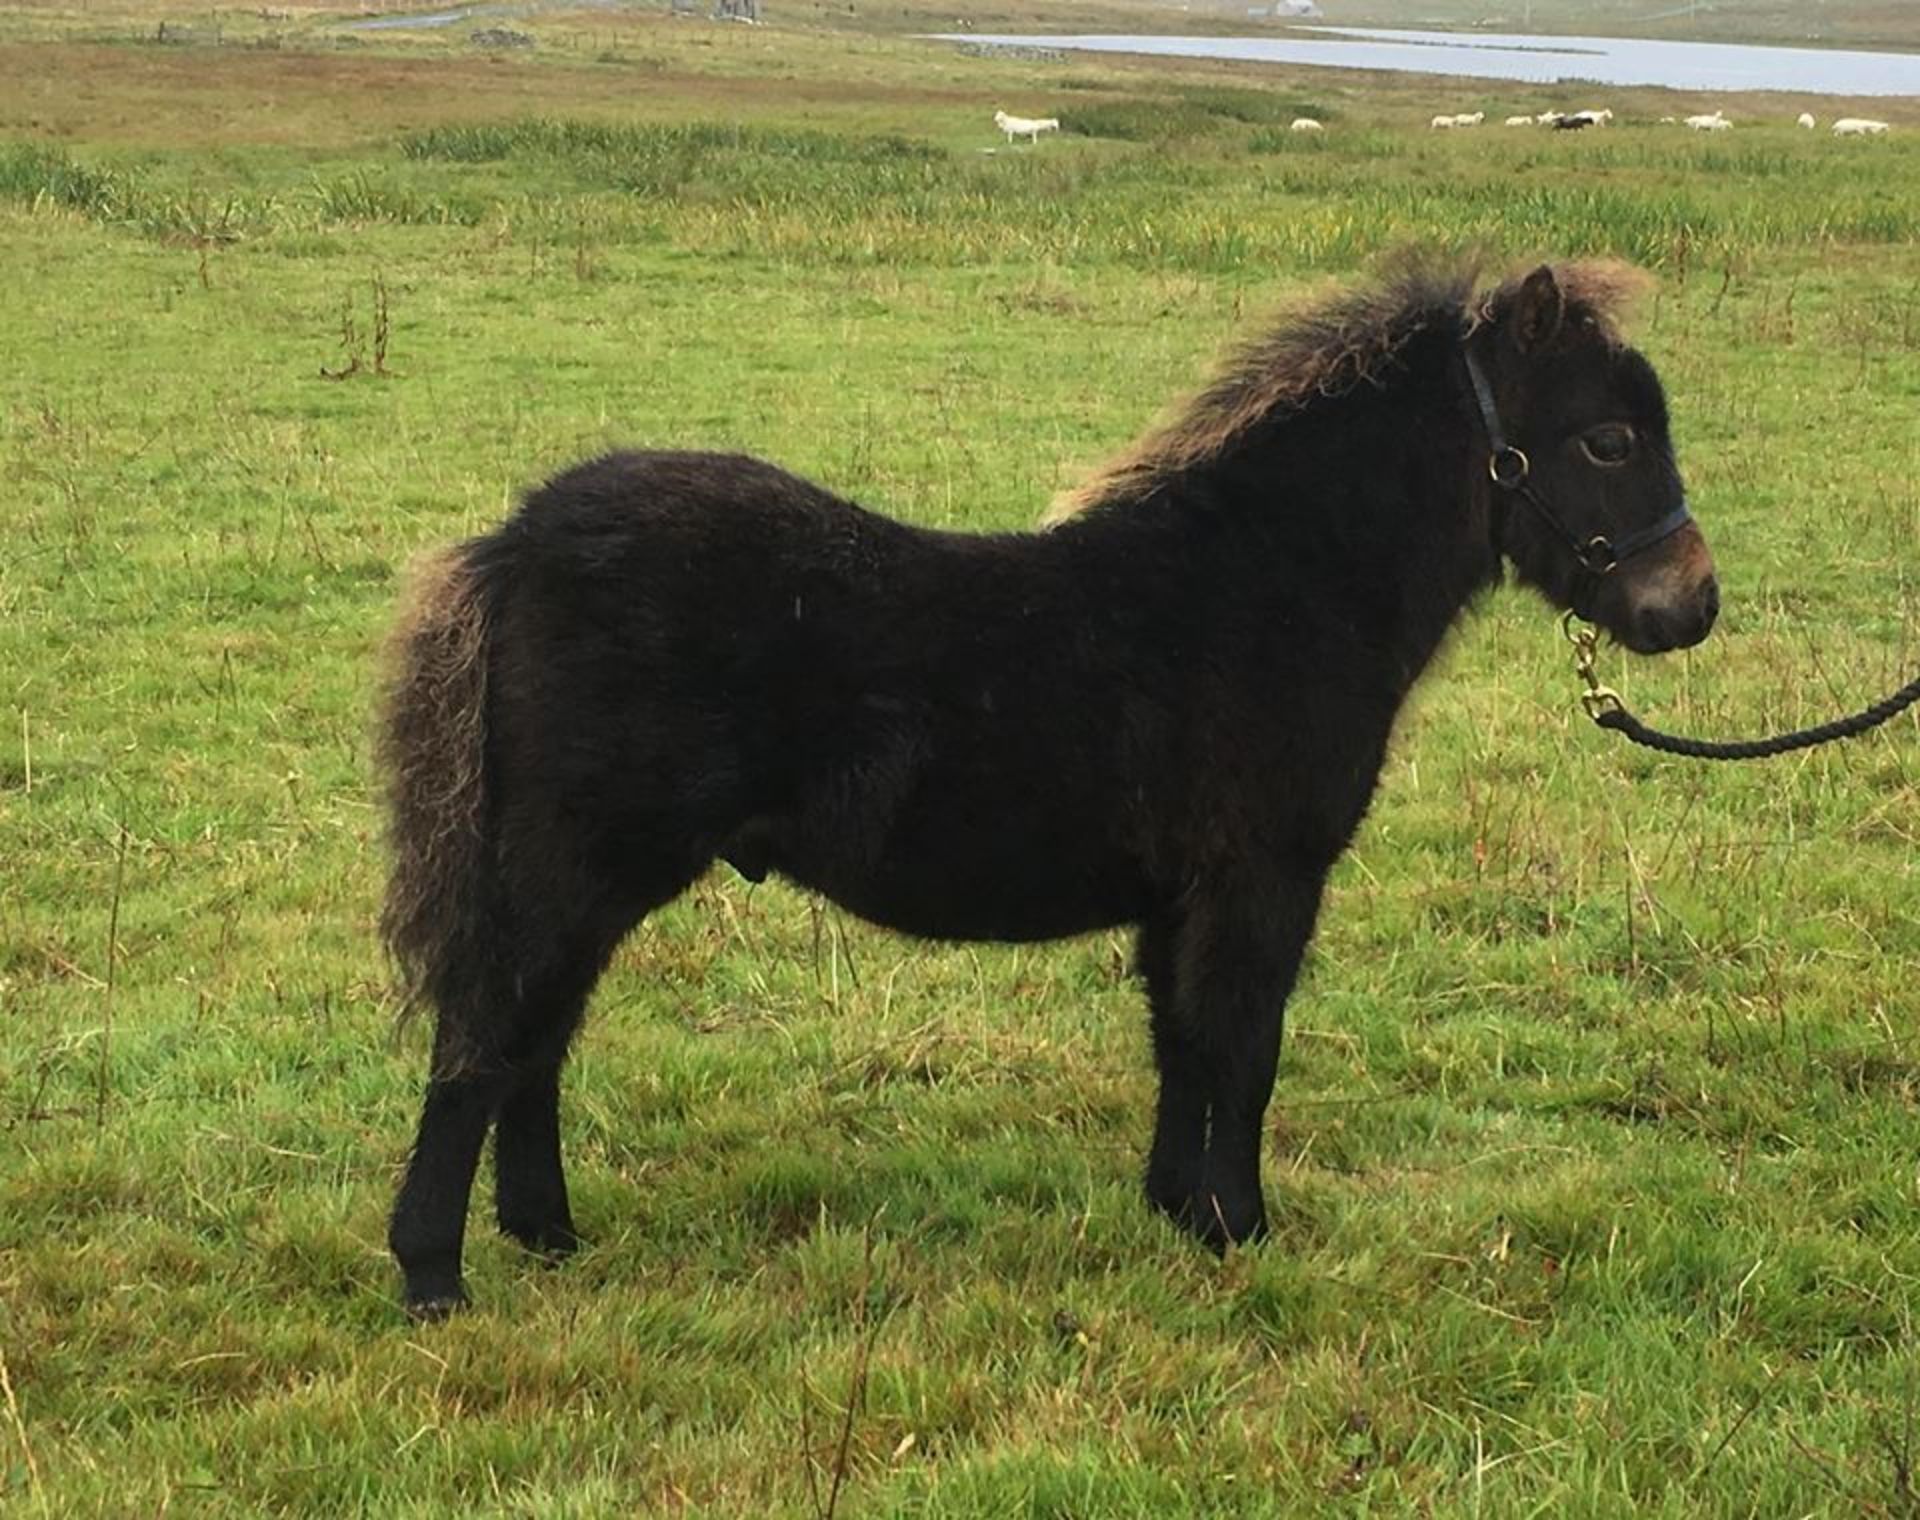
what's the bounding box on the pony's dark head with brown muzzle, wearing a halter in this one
[1465,265,1720,654]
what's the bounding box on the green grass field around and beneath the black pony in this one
[0,6,1920,1518]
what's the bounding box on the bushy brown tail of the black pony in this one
[378,545,488,1034]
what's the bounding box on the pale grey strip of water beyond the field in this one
[941,27,1920,96]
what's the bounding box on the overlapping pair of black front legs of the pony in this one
[1140,877,1323,1249]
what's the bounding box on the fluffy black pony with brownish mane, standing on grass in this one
[382,265,1718,1317]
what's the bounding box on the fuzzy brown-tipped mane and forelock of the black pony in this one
[1043,259,1647,524]
